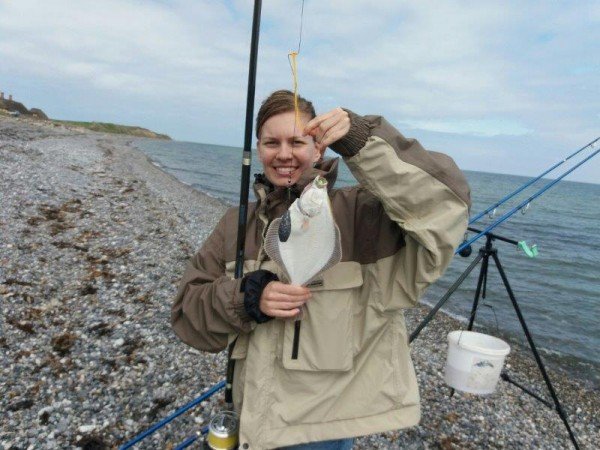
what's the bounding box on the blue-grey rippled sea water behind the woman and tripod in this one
[138,140,600,383]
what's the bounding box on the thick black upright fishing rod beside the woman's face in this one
[225,0,262,409]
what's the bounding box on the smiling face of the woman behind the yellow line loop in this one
[257,111,321,186]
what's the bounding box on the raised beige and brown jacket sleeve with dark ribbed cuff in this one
[332,112,470,308]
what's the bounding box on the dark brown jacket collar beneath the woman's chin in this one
[254,158,339,222]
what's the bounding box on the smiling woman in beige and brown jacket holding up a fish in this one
[172,91,470,449]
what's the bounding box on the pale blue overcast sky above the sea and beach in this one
[0,0,600,183]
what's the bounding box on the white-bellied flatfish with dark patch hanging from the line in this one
[265,176,342,286]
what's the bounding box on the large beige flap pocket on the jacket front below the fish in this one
[282,262,363,371]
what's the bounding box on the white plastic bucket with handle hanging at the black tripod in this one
[444,330,510,394]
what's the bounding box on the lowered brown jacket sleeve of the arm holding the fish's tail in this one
[171,215,253,352]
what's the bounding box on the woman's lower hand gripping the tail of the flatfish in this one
[259,281,312,318]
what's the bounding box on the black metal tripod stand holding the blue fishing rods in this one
[409,228,579,449]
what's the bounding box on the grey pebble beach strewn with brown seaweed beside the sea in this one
[0,116,600,450]
